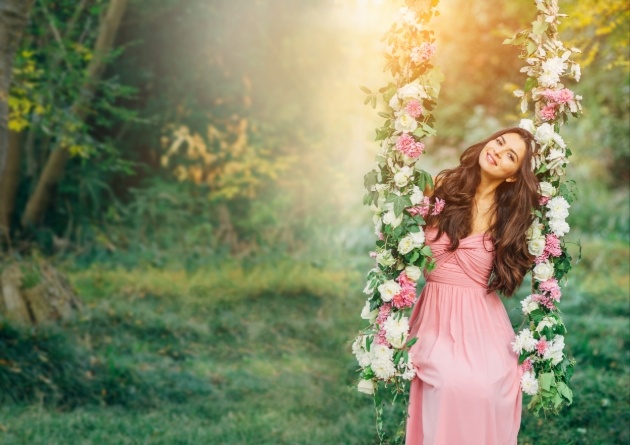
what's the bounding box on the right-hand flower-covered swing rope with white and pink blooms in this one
[503,0,582,415]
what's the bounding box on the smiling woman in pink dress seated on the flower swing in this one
[406,128,538,445]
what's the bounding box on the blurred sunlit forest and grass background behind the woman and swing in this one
[0,0,630,445]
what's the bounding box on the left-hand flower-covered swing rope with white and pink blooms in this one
[352,0,444,443]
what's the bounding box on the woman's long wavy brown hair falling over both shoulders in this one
[427,127,538,297]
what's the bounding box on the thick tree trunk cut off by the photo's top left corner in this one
[0,0,34,178]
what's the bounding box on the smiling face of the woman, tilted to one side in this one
[479,133,527,182]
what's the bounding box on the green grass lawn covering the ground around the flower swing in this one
[0,239,630,445]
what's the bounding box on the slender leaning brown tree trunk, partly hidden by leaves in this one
[22,0,127,226]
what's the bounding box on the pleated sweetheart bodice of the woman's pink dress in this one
[425,227,494,288]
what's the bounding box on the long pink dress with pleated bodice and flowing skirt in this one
[406,228,523,445]
